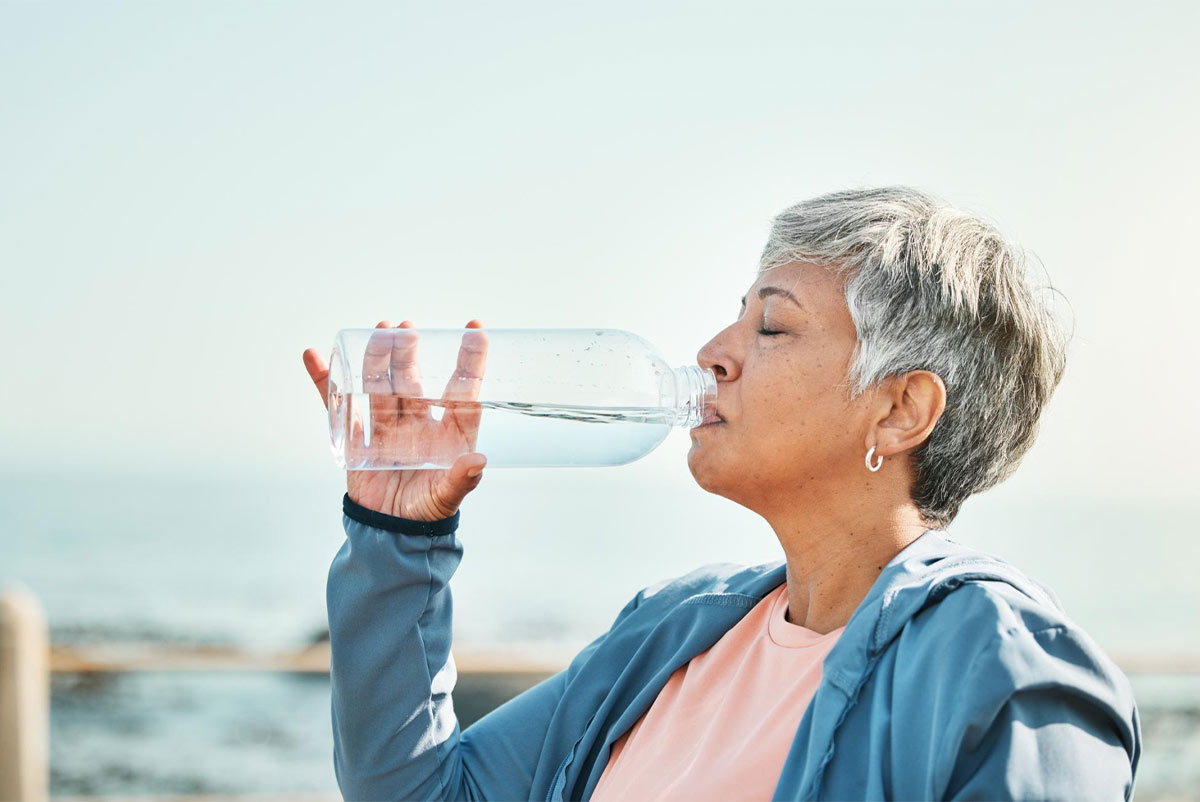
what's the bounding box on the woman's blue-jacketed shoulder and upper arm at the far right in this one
[898,580,1141,798]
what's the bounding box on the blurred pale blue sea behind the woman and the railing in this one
[0,463,1200,800]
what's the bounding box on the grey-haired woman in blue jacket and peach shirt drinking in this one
[305,187,1141,800]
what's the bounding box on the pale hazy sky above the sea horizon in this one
[0,1,1200,503]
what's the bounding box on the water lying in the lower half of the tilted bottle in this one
[332,393,677,471]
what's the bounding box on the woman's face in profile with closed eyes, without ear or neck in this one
[688,263,866,514]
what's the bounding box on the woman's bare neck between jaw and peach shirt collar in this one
[767,499,931,634]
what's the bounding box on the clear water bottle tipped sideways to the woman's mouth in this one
[328,328,716,471]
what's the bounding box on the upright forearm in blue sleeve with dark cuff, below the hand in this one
[326,494,462,800]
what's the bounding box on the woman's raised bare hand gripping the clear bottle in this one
[304,321,487,521]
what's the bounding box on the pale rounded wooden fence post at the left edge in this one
[0,588,50,802]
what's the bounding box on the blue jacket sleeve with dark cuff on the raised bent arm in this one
[326,498,641,800]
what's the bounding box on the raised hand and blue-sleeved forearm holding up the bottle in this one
[314,321,501,798]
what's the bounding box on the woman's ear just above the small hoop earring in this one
[865,370,946,456]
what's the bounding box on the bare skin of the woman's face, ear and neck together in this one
[688,263,946,633]
